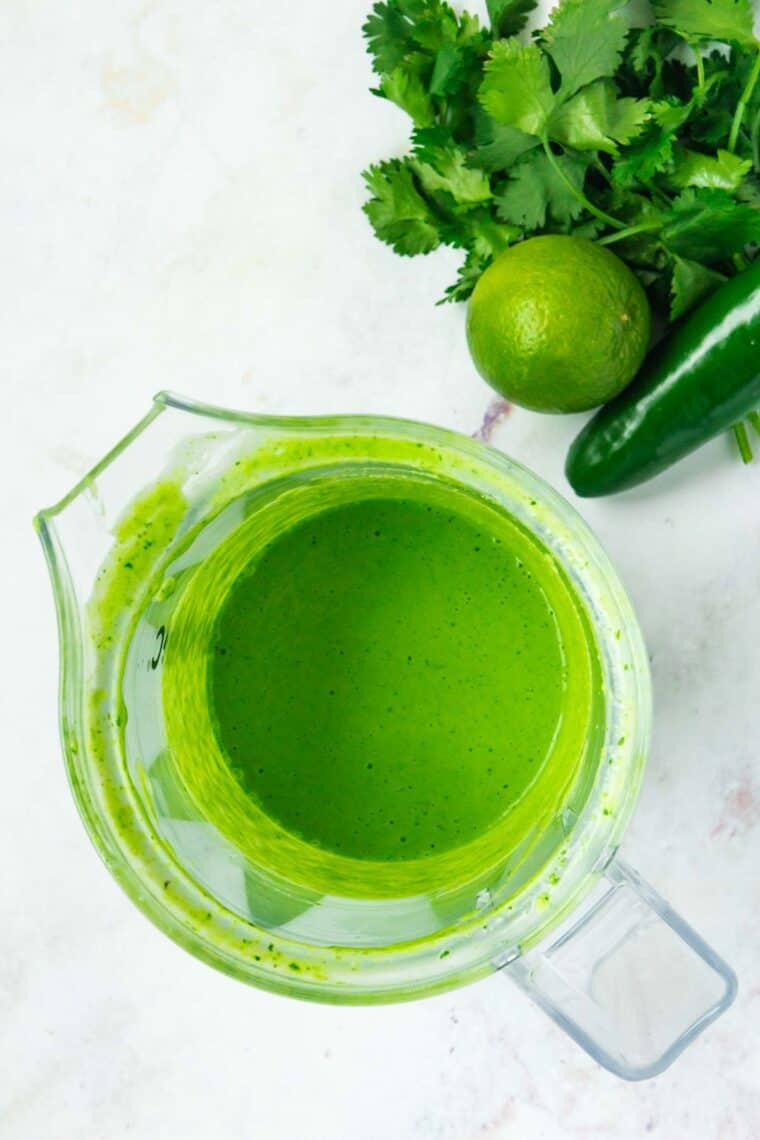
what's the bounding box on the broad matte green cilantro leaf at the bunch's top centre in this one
[544,0,628,98]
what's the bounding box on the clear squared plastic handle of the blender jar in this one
[501,858,736,1081]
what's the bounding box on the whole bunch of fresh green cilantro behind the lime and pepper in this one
[363,0,760,321]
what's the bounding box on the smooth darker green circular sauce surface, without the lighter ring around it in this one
[210,498,565,860]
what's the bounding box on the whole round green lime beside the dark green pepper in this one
[467,235,651,412]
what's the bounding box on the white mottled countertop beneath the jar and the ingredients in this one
[0,0,760,1140]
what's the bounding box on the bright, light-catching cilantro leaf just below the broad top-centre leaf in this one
[549,80,649,155]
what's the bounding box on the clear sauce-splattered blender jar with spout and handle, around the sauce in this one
[35,393,736,1080]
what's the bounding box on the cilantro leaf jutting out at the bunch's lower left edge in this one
[362,158,442,250]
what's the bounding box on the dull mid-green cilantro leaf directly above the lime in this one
[496,150,588,229]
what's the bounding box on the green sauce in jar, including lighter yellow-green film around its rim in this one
[164,469,595,896]
